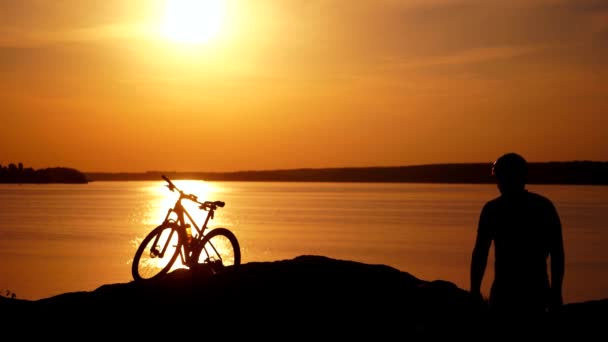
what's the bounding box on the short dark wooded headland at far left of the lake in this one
[0,163,88,183]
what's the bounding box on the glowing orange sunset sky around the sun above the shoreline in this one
[0,0,608,172]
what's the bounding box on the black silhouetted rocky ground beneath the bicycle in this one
[0,256,608,340]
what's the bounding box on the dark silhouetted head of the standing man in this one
[492,153,528,194]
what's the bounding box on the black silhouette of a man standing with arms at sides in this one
[470,153,564,318]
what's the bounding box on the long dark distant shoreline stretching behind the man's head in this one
[85,161,608,185]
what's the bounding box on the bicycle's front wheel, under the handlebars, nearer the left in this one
[131,223,181,281]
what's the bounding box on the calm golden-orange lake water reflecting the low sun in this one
[0,180,608,303]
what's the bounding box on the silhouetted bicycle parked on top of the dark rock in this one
[131,175,241,281]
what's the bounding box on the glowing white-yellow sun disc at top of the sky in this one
[161,0,224,44]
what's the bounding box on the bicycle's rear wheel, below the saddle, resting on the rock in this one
[194,228,241,271]
